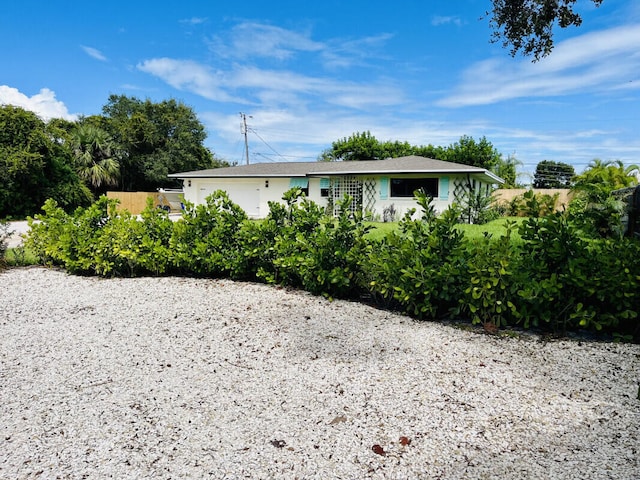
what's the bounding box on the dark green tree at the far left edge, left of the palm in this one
[0,105,91,218]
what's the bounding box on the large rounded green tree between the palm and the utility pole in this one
[101,95,228,191]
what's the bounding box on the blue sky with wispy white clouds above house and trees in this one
[0,0,640,182]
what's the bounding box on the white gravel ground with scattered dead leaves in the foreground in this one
[0,268,640,480]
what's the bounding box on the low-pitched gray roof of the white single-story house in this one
[169,155,504,183]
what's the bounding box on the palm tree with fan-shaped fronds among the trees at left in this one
[71,125,120,191]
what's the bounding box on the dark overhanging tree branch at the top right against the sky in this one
[487,0,602,61]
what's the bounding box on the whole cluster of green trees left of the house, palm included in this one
[0,95,229,218]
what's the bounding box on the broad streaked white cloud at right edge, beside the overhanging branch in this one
[438,25,640,107]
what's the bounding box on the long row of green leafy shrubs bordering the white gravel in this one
[27,189,640,339]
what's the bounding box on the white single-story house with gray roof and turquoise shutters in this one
[169,156,503,219]
